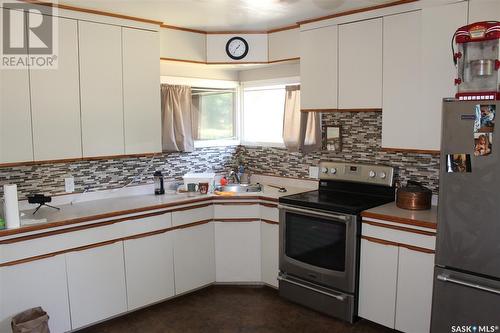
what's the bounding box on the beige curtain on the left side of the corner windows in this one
[161,84,194,152]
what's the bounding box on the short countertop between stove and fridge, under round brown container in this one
[361,202,437,229]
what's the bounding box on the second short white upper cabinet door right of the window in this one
[339,18,382,109]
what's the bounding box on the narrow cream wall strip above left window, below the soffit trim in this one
[160,60,238,81]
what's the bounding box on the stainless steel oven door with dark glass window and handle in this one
[279,205,358,293]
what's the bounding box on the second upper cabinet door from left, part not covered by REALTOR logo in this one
[30,18,82,161]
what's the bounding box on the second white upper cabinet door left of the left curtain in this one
[78,21,125,157]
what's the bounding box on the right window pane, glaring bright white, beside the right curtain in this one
[241,78,298,147]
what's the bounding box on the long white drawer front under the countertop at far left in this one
[0,213,172,263]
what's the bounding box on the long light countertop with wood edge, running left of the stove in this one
[0,185,308,237]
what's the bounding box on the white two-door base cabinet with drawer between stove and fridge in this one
[358,218,436,333]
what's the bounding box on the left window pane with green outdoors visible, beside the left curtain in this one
[191,87,236,141]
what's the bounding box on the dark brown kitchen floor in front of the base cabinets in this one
[79,285,396,333]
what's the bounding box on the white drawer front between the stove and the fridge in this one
[361,223,436,250]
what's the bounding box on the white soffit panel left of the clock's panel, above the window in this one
[160,28,207,62]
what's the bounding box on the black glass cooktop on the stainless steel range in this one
[279,185,394,215]
